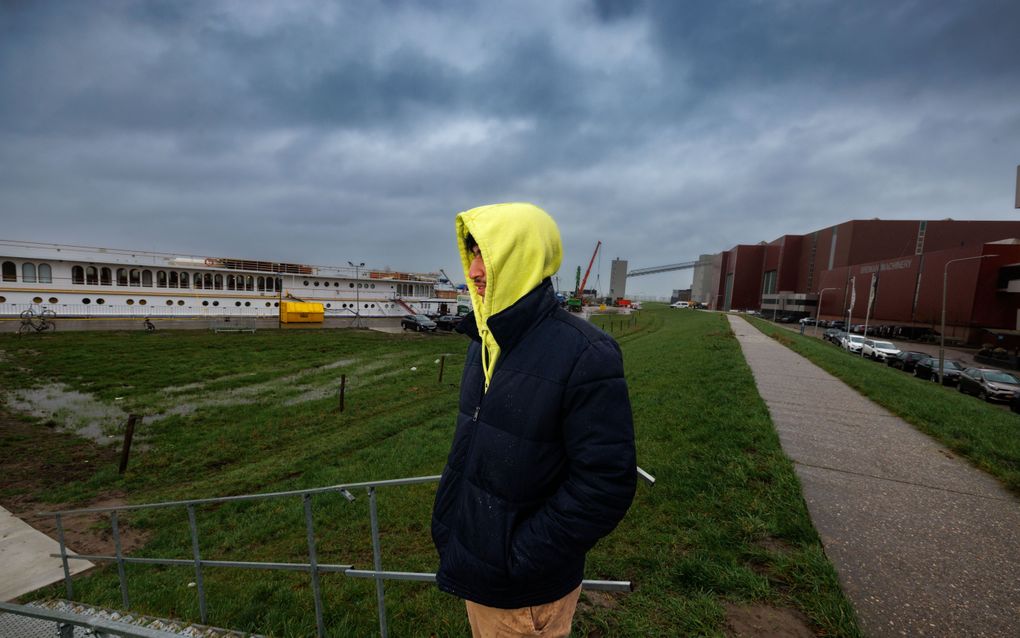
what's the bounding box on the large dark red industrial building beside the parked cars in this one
[692,219,1020,348]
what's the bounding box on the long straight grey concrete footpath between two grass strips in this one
[727,315,1020,638]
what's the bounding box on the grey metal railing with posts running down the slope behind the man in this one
[37,468,655,638]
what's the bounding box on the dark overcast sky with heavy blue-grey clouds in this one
[0,0,1020,295]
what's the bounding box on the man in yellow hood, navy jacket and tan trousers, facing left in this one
[432,203,636,636]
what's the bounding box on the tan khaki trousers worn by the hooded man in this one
[464,585,580,638]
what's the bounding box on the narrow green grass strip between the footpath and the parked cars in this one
[745,316,1020,496]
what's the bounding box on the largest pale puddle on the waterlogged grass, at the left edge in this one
[5,384,128,445]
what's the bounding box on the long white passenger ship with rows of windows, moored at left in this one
[0,240,457,318]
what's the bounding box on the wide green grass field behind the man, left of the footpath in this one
[0,307,860,636]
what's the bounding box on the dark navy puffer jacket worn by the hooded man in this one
[432,280,636,608]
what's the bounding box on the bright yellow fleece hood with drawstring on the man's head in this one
[457,203,563,390]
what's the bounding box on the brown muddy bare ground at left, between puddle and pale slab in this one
[0,408,146,555]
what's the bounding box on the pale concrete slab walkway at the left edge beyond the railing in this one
[0,507,92,602]
